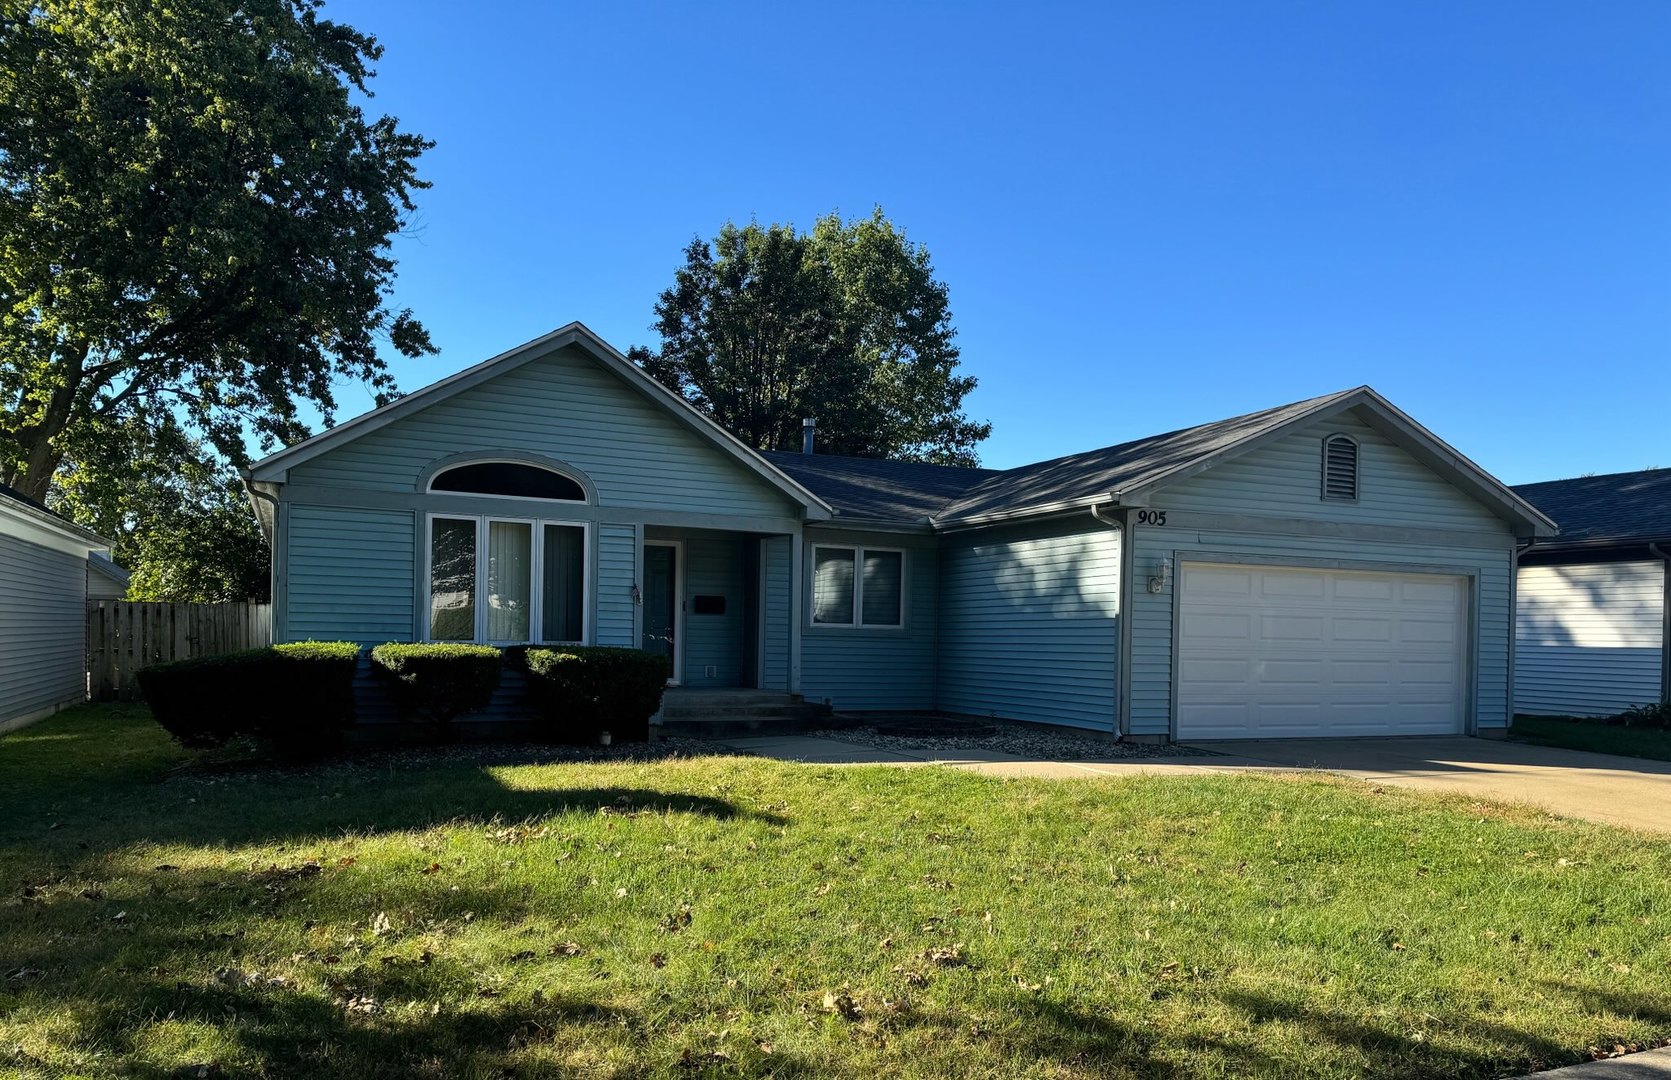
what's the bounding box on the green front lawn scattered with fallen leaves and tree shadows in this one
[0,709,1671,1078]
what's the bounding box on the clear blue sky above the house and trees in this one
[326,0,1671,483]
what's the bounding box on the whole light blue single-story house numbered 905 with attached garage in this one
[246,323,1554,739]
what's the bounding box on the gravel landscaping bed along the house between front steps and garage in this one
[805,716,1211,761]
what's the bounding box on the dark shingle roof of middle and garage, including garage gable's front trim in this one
[769,386,1556,535]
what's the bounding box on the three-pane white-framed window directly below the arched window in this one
[428,513,588,644]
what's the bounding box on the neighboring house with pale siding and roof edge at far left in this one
[0,485,110,731]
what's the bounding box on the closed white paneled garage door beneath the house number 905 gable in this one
[1178,563,1467,739]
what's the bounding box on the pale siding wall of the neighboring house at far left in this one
[0,535,87,729]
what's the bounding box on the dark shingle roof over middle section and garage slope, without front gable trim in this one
[764,390,1357,523]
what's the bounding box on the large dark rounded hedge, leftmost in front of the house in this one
[139,642,359,756]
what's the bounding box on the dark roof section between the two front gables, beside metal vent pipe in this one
[762,450,1003,525]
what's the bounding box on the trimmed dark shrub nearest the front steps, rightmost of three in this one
[521,647,673,742]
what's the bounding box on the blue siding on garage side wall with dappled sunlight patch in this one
[939,517,1120,731]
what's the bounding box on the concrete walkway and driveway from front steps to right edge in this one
[727,736,1671,833]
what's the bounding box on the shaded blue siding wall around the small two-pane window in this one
[800,528,939,712]
